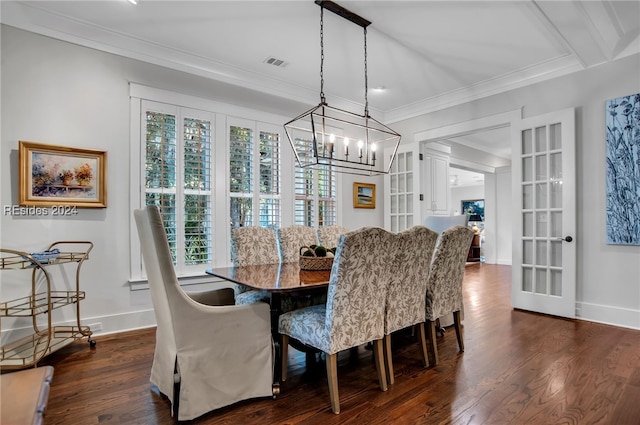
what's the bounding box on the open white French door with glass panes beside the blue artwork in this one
[511,108,576,318]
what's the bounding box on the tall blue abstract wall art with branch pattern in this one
[606,93,640,245]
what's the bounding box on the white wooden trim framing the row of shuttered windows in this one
[129,82,342,284]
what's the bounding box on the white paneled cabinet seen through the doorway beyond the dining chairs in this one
[421,143,451,217]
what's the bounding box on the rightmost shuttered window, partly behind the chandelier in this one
[294,139,336,227]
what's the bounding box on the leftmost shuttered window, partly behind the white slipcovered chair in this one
[143,102,212,273]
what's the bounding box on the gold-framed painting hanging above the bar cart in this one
[18,140,107,208]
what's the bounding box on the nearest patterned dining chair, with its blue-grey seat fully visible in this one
[278,227,396,413]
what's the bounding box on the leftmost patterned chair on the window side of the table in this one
[231,226,280,304]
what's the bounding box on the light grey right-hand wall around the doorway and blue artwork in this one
[392,54,640,329]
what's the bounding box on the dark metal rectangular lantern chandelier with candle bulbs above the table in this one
[284,0,400,175]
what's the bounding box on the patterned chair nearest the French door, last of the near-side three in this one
[426,226,473,364]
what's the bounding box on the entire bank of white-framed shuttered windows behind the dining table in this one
[130,83,336,282]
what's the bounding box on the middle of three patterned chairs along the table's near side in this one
[384,226,438,385]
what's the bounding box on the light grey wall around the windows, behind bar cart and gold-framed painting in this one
[0,25,384,342]
